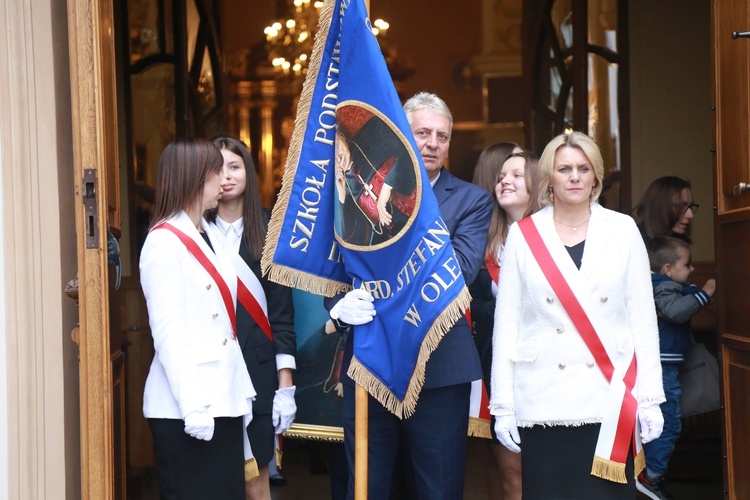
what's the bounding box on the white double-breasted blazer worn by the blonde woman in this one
[490,203,665,427]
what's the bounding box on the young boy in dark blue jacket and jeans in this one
[636,236,716,500]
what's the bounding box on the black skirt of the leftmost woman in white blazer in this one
[148,417,245,500]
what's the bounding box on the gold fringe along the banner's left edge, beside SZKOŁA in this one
[260,0,351,297]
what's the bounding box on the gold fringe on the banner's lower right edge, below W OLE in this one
[347,286,471,419]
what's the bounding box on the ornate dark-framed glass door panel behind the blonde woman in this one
[524,0,630,210]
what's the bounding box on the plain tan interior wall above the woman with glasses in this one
[629,0,714,261]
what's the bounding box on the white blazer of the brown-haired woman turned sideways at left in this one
[140,212,255,419]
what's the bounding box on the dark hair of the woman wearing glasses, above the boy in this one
[633,175,692,241]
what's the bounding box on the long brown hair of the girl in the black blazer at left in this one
[206,136,266,260]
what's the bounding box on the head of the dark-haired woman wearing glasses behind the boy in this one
[633,176,698,244]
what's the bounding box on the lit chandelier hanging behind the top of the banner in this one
[263,0,389,84]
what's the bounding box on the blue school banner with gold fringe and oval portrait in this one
[263,0,469,417]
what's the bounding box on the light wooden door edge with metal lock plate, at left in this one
[68,0,125,499]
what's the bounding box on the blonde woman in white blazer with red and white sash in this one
[490,132,664,499]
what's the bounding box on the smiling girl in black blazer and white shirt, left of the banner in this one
[208,137,297,500]
